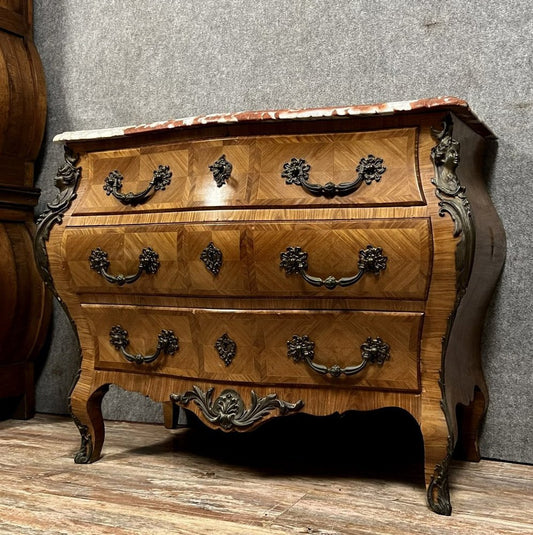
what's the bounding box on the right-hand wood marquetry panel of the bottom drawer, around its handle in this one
[259,310,423,390]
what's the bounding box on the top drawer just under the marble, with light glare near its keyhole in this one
[74,128,424,215]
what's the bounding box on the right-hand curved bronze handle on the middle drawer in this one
[279,245,387,290]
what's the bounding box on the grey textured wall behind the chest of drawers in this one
[34,0,533,463]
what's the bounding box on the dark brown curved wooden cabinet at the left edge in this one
[0,0,50,418]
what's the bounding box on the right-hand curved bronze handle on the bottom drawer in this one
[287,334,390,377]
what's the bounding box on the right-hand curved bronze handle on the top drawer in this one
[281,154,387,198]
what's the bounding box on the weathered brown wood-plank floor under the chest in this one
[0,415,533,535]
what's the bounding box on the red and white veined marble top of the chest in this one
[54,97,495,143]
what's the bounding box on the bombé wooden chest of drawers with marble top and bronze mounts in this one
[35,98,505,514]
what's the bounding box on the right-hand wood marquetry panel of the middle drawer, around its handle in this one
[249,219,431,299]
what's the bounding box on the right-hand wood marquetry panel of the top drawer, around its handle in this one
[252,128,424,206]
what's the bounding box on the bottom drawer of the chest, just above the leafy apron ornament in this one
[82,304,423,391]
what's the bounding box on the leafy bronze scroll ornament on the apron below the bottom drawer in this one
[170,386,304,431]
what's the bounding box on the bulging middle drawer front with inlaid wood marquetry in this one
[64,218,431,300]
